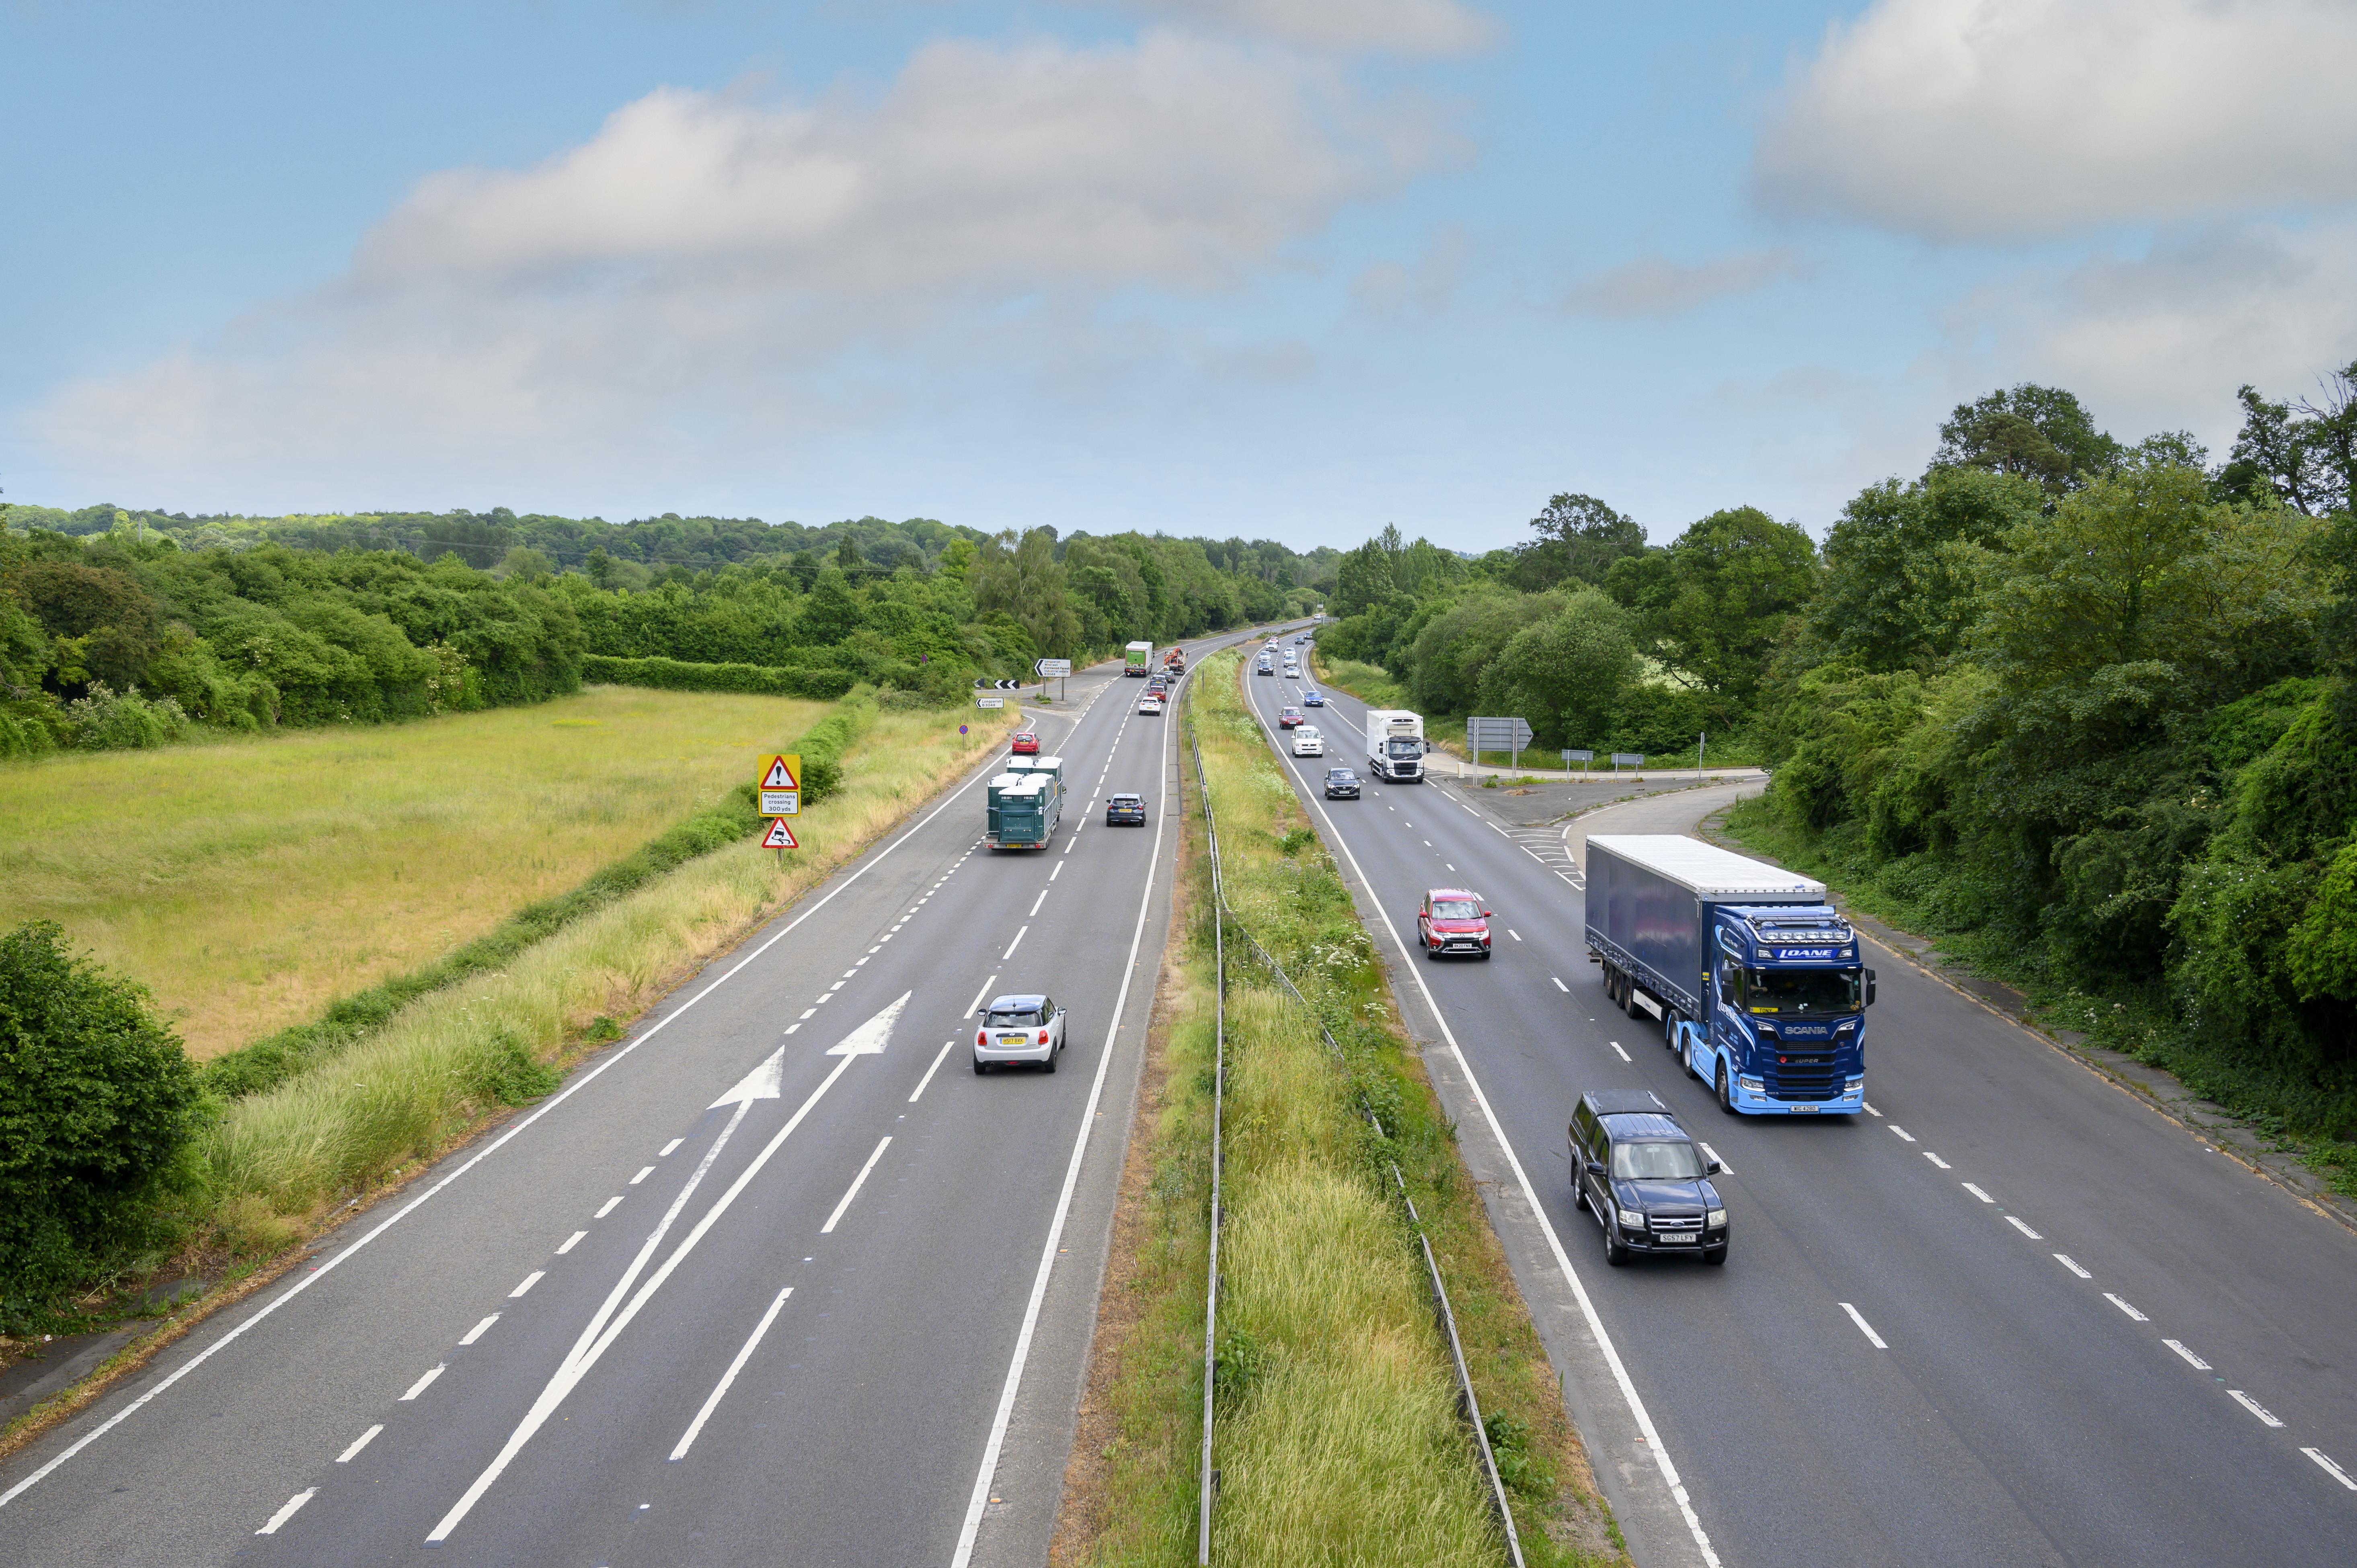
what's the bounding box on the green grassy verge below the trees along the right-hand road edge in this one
[1721,794,2357,1198]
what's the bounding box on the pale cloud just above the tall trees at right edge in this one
[1947,219,2357,436]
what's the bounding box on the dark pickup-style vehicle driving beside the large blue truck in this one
[1570,1089,1728,1266]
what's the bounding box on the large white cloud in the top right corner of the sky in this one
[1751,0,2357,240]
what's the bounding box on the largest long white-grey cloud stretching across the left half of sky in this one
[33,33,1464,497]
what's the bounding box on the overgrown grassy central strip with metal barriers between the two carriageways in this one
[1053,658,1619,1566]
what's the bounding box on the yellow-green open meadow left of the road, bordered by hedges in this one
[0,686,829,1061]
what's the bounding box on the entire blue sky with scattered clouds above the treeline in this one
[0,0,2357,549]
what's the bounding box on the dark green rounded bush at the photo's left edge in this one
[0,919,198,1332]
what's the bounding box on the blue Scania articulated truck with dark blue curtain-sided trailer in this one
[1586,835,1874,1115]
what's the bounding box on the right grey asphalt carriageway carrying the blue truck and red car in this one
[1244,655,2357,1568]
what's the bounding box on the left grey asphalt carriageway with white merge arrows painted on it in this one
[0,622,1291,1568]
